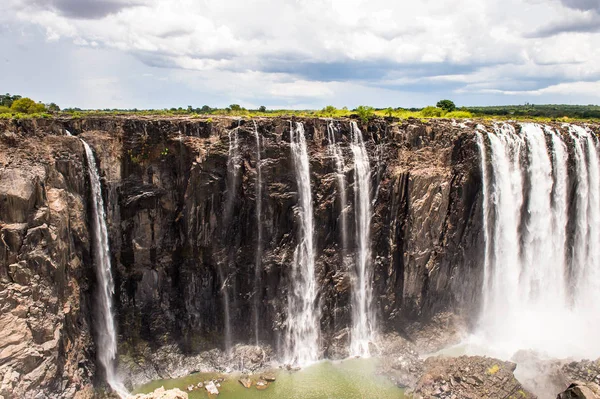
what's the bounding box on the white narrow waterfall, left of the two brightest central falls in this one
[285,122,320,365]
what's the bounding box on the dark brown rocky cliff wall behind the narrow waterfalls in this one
[0,117,483,397]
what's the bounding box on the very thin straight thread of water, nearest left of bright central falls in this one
[254,121,262,345]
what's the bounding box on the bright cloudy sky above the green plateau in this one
[0,0,600,109]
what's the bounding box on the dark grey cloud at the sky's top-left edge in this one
[30,0,143,19]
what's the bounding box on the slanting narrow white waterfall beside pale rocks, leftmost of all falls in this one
[81,140,127,397]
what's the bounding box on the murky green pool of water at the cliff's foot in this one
[134,359,404,399]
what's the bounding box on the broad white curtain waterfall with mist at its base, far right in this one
[477,124,600,358]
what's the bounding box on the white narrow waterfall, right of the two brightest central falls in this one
[350,122,375,356]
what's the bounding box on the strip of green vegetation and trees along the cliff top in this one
[0,93,600,122]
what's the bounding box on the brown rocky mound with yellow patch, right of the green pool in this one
[407,356,536,399]
